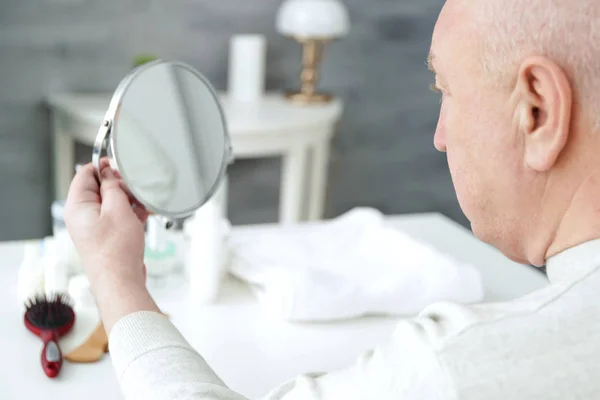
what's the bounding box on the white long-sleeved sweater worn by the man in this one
[110,240,600,400]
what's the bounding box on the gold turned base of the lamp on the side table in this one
[284,37,333,105]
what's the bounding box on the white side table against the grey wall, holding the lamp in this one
[46,93,342,223]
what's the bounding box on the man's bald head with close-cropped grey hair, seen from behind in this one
[429,0,600,265]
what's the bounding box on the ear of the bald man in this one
[516,56,573,172]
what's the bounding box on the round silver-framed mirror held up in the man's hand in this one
[92,60,233,227]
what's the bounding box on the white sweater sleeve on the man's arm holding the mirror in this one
[109,311,453,400]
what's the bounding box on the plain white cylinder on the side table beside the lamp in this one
[228,35,266,102]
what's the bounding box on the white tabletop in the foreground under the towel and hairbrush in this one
[0,214,547,400]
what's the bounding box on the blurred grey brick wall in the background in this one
[0,0,465,240]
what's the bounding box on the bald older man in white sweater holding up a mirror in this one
[66,0,600,400]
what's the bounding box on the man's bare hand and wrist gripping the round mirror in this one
[65,159,157,331]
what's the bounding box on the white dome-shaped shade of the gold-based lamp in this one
[276,0,350,38]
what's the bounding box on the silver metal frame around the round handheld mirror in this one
[92,59,234,223]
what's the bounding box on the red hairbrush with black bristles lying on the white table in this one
[23,293,75,378]
